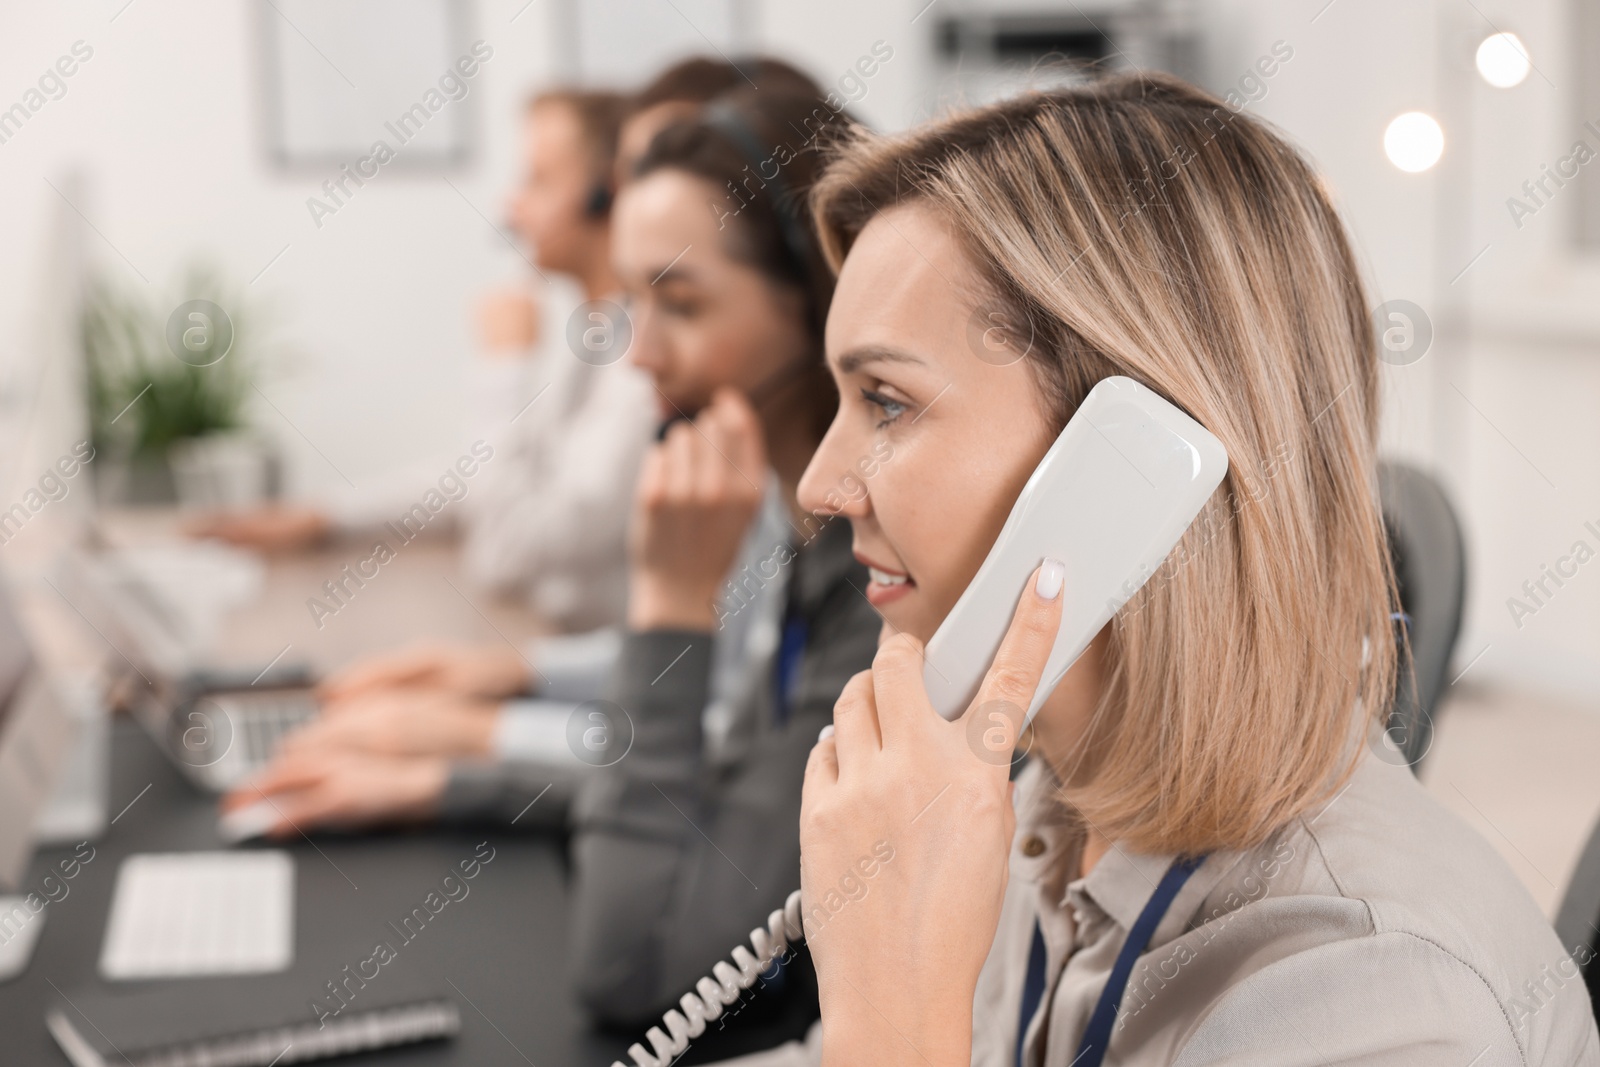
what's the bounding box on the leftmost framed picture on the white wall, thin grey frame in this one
[256,0,473,171]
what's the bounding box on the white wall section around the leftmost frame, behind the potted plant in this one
[0,0,563,490]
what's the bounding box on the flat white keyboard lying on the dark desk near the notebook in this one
[99,849,294,979]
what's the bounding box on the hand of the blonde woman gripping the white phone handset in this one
[800,560,1062,1067]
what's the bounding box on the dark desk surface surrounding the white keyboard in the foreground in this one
[0,721,638,1067]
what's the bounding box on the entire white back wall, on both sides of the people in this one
[0,0,1600,699]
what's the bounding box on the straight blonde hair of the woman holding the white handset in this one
[813,74,1397,853]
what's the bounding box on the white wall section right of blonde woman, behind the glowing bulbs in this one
[1214,0,1600,701]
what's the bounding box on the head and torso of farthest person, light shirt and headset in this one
[462,90,654,629]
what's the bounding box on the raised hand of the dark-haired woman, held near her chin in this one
[627,389,768,630]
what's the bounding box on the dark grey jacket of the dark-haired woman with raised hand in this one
[571,520,882,1024]
